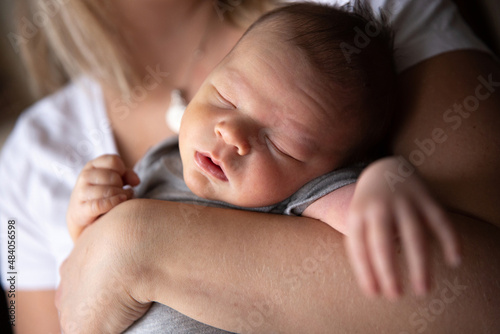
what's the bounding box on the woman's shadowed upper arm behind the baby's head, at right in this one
[393,51,500,226]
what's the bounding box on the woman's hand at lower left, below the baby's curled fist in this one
[56,201,150,334]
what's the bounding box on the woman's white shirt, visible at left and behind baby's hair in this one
[0,0,489,290]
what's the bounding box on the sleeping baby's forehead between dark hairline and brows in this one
[225,24,344,124]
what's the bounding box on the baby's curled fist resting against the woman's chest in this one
[66,155,140,241]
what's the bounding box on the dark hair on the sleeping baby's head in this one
[244,1,396,165]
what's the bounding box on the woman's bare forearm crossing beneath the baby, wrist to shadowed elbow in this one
[122,200,500,333]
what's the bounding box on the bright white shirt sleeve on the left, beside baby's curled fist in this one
[0,80,116,290]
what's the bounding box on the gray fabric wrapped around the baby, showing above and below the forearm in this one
[125,138,364,334]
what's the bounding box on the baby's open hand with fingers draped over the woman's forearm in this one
[345,158,460,299]
